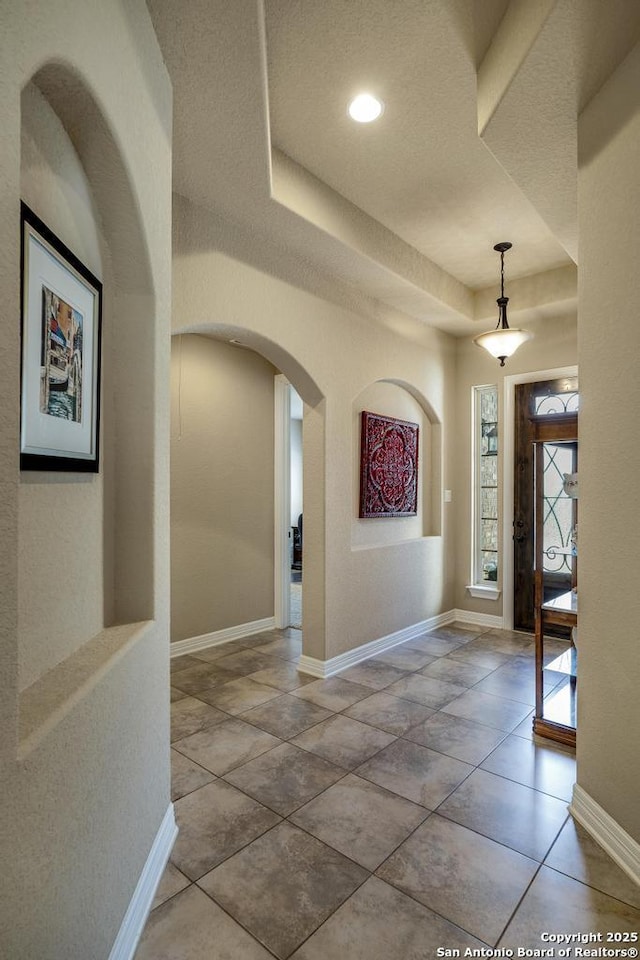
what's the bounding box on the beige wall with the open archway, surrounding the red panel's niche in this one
[174,198,454,659]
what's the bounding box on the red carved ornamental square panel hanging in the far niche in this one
[360,410,418,518]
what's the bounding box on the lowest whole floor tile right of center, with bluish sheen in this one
[378,814,539,946]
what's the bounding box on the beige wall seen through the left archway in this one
[171,335,277,640]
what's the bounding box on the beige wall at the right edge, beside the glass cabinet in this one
[578,47,640,843]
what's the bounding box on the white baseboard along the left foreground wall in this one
[109,803,178,960]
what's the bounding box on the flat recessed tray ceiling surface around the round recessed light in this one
[265,0,569,289]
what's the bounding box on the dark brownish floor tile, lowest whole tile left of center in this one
[200,823,367,958]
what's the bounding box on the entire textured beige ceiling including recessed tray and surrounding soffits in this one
[148,0,640,335]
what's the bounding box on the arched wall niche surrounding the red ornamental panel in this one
[351,377,442,550]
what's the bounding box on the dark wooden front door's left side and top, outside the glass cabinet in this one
[513,377,578,632]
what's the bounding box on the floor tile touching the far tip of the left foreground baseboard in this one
[171,780,280,880]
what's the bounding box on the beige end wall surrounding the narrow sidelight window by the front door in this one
[451,307,578,616]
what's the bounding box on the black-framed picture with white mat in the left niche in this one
[20,203,102,473]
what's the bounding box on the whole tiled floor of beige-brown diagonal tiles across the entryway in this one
[136,624,640,960]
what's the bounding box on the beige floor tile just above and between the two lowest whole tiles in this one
[290,774,429,870]
